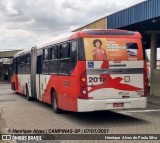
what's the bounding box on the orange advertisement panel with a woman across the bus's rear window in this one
[84,38,143,61]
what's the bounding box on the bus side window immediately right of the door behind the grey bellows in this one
[42,48,49,73]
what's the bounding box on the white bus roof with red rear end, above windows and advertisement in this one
[14,29,142,57]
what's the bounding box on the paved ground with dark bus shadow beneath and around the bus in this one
[0,83,160,143]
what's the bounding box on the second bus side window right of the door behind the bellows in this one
[49,46,58,74]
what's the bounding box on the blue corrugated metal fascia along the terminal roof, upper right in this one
[107,0,160,28]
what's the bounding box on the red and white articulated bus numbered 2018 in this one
[11,29,147,113]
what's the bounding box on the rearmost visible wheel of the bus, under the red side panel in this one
[52,92,61,114]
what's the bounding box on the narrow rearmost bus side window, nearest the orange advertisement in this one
[70,41,78,73]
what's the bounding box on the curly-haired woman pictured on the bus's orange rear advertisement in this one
[92,39,107,61]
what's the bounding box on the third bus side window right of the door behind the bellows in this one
[58,43,70,74]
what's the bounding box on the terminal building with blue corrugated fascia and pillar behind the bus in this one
[74,0,160,96]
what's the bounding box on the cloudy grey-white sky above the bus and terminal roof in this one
[0,0,145,51]
